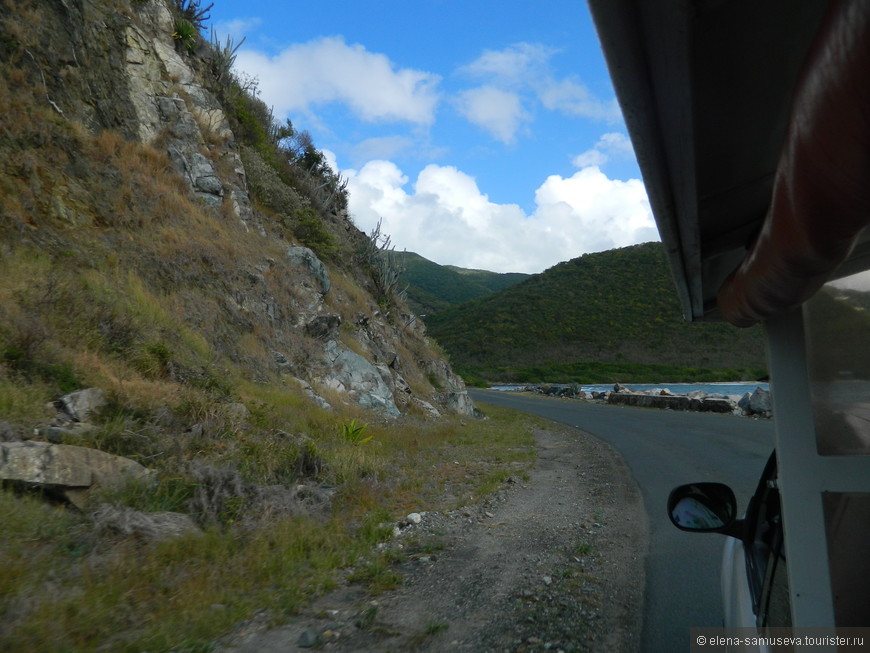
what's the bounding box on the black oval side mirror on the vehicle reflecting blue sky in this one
[668,483,740,537]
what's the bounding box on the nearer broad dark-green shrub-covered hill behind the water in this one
[426,243,766,383]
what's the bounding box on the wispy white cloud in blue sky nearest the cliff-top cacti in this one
[236,37,440,125]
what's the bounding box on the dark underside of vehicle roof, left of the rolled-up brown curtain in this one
[590,0,868,320]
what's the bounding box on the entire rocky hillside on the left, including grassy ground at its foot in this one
[0,0,490,653]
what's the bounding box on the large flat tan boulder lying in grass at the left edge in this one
[0,441,152,507]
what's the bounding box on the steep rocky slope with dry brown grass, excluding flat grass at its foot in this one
[0,0,472,424]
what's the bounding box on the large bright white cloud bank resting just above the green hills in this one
[344,161,658,272]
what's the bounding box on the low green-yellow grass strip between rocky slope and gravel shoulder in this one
[0,406,537,653]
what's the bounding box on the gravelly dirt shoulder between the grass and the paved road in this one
[218,424,648,653]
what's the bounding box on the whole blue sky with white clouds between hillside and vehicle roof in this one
[202,0,659,273]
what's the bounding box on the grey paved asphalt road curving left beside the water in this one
[469,389,773,653]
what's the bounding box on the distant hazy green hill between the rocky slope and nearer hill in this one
[391,252,529,315]
